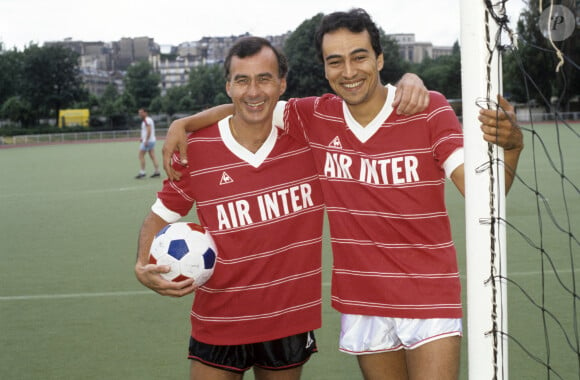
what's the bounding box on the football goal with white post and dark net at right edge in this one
[461,0,580,380]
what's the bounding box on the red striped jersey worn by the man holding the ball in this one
[153,119,324,345]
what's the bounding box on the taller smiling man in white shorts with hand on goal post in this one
[164,9,523,380]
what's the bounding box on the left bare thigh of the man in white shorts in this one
[357,350,408,380]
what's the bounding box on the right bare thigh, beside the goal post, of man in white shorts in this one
[407,336,461,380]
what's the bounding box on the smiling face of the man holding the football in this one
[226,47,286,128]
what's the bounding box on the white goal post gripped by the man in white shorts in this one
[460,0,508,380]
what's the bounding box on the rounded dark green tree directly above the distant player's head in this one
[125,61,161,111]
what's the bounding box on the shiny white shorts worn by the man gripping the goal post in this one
[339,314,463,355]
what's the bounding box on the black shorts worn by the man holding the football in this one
[188,331,318,373]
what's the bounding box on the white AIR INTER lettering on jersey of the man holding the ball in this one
[216,183,314,230]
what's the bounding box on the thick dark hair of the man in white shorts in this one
[314,8,383,62]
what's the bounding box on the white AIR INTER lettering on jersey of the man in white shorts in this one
[324,152,419,185]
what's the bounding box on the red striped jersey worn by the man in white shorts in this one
[284,87,463,318]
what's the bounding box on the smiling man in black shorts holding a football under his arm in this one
[135,37,324,380]
